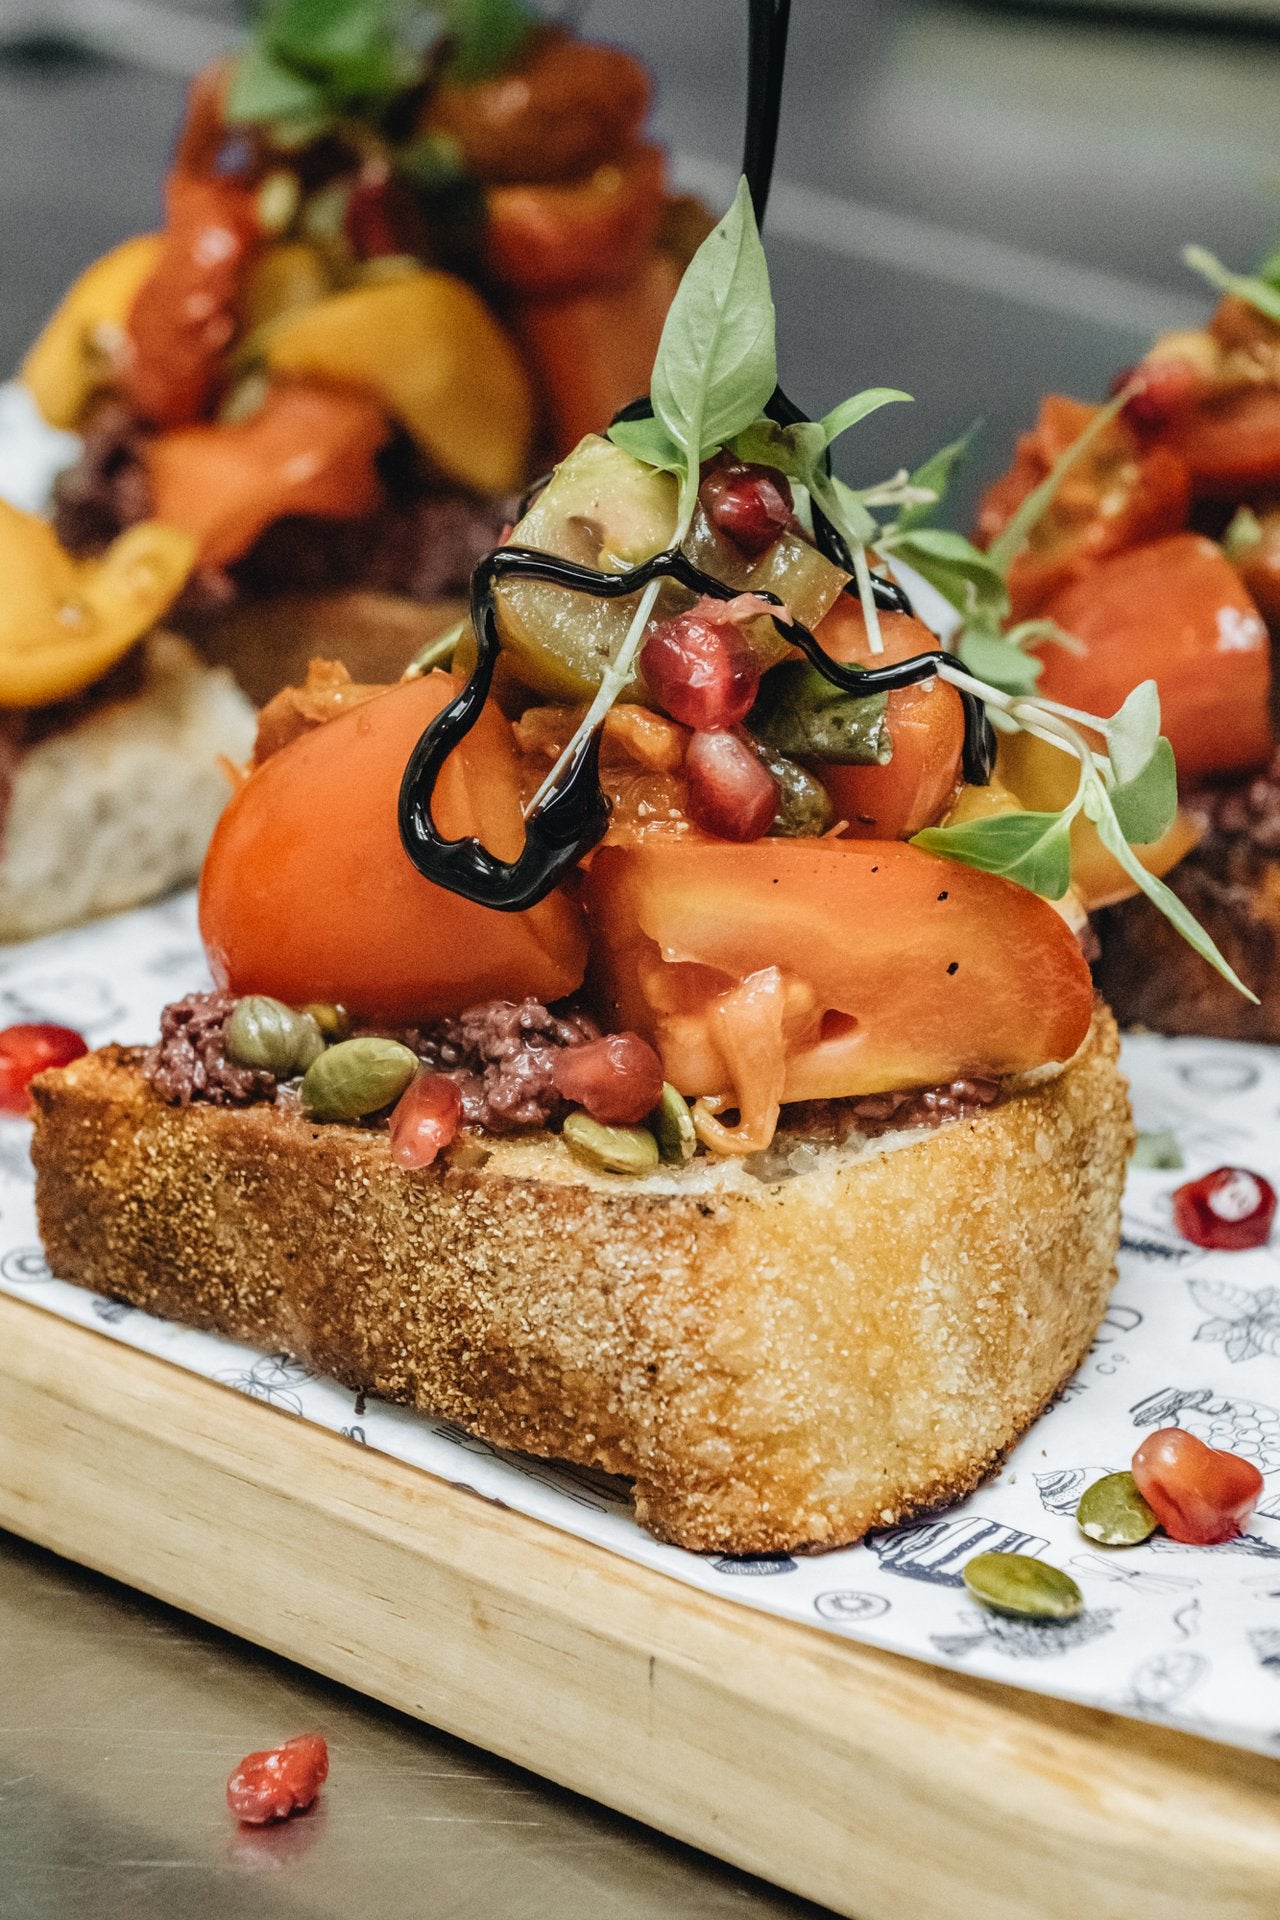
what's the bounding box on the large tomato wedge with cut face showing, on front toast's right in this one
[587,837,1094,1133]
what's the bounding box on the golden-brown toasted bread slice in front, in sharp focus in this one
[33,1010,1132,1553]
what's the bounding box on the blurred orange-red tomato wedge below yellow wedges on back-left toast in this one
[144,380,391,566]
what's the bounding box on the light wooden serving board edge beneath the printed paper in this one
[0,1296,1280,1920]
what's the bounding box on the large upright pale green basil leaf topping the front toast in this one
[651,180,777,516]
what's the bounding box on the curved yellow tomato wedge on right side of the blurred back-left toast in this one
[263,269,533,493]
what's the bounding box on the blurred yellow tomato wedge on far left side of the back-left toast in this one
[21,234,161,428]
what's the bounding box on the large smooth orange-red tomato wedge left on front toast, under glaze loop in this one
[200,674,585,1021]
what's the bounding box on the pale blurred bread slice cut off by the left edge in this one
[0,634,255,941]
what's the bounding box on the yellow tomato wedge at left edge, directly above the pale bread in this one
[0,503,196,707]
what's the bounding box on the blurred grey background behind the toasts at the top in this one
[0,0,1280,513]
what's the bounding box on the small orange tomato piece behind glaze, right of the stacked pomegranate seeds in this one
[816,593,965,839]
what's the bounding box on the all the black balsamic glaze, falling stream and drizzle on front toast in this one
[399,0,996,914]
